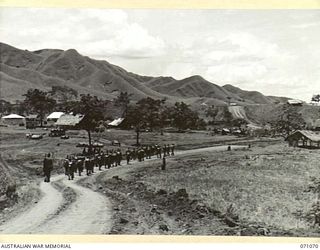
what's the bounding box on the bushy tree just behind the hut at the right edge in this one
[271,104,306,137]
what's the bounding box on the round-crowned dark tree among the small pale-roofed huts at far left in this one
[23,89,56,127]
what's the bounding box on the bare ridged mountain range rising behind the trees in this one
[0,43,288,107]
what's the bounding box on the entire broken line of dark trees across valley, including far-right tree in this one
[0,86,312,144]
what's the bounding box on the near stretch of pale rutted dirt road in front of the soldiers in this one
[0,176,111,234]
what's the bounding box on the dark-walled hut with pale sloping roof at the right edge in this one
[286,130,320,148]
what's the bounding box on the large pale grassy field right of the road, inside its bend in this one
[143,144,319,235]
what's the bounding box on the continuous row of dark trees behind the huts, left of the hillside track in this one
[1,87,206,145]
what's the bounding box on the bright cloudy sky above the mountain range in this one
[0,8,320,101]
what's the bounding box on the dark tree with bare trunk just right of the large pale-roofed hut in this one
[69,94,105,149]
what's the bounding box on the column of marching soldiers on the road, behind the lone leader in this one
[59,144,175,180]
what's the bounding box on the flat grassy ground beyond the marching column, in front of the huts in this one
[0,127,241,165]
